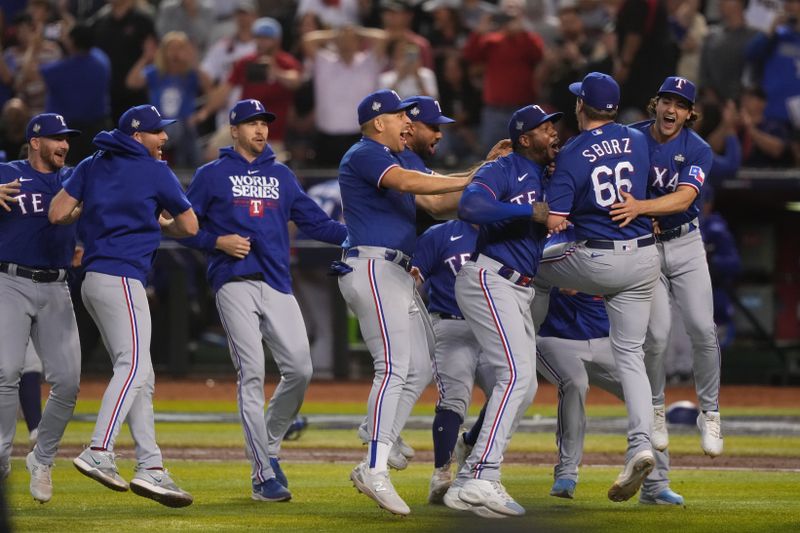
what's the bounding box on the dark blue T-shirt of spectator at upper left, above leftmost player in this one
[39,48,111,124]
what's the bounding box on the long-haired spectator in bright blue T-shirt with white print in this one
[126,31,211,168]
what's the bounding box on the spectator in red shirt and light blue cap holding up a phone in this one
[196,17,302,160]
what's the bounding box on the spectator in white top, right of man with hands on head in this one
[378,41,439,98]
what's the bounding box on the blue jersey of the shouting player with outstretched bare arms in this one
[339,137,417,255]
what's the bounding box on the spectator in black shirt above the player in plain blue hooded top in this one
[90,0,156,122]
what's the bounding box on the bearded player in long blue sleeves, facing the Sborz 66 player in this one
[444,105,562,517]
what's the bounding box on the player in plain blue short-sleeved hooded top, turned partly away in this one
[49,105,198,507]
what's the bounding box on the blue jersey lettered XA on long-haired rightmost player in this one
[631,120,714,230]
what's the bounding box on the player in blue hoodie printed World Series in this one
[184,100,347,501]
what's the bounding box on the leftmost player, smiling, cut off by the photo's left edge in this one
[0,113,81,503]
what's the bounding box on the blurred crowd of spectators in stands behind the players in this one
[0,0,800,172]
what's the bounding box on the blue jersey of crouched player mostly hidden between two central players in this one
[411,220,478,316]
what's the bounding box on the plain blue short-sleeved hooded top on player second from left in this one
[64,130,192,284]
